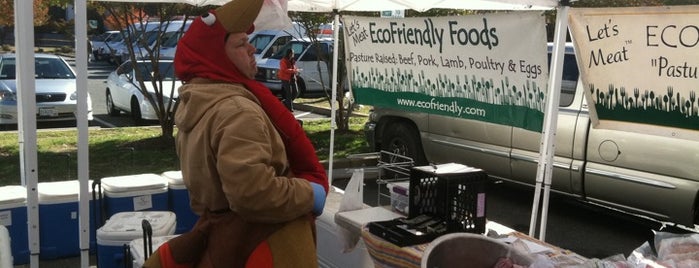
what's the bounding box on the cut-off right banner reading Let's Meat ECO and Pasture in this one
[570,6,699,140]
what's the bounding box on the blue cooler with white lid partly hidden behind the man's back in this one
[161,171,199,234]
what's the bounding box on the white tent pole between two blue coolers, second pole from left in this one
[74,0,91,268]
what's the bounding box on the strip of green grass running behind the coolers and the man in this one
[0,117,369,185]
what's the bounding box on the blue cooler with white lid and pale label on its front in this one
[101,173,168,217]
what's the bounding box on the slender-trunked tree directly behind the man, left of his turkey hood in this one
[101,2,210,143]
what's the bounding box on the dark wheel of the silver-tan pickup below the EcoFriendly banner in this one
[381,122,428,166]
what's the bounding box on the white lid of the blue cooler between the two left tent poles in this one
[37,180,92,204]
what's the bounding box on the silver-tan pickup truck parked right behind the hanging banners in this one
[365,44,699,227]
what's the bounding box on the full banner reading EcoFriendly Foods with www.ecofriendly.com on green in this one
[343,12,548,132]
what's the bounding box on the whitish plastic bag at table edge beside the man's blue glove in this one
[337,169,364,253]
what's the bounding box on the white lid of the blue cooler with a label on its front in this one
[101,173,167,193]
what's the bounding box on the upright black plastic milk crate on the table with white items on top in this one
[408,163,488,234]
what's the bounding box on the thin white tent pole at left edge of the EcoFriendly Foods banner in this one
[328,9,340,189]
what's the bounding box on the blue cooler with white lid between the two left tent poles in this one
[37,180,97,259]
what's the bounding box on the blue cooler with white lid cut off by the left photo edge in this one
[0,185,29,265]
